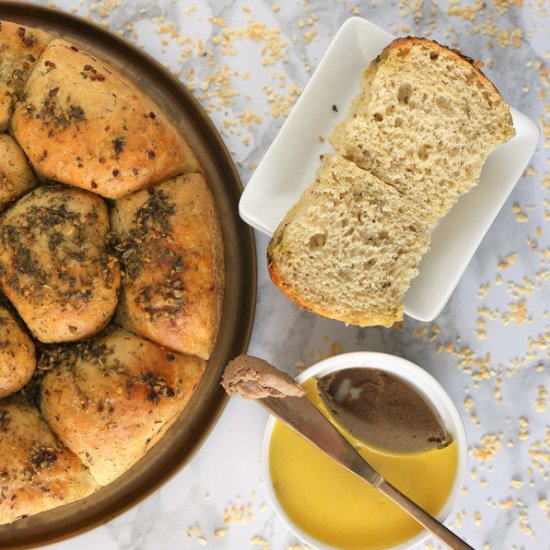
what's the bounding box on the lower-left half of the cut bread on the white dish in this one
[268,155,429,326]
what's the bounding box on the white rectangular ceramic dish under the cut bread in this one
[239,17,540,321]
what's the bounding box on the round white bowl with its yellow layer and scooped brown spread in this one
[263,353,466,550]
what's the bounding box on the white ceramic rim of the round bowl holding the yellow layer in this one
[261,351,468,550]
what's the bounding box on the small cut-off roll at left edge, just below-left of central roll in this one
[0,305,36,398]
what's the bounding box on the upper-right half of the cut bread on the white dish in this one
[330,37,515,224]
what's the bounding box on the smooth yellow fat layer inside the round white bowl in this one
[269,379,457,550]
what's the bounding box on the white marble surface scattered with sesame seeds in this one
[18,0,550,550]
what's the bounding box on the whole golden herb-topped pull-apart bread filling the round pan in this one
[0,22,224,529]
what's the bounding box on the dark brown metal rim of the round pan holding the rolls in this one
[0,2,256,549]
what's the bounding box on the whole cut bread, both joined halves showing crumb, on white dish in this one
[268,37,515,326]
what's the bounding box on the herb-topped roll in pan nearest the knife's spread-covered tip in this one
[41,330,206,485]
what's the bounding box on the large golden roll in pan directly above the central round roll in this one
[12,40,201,198]
